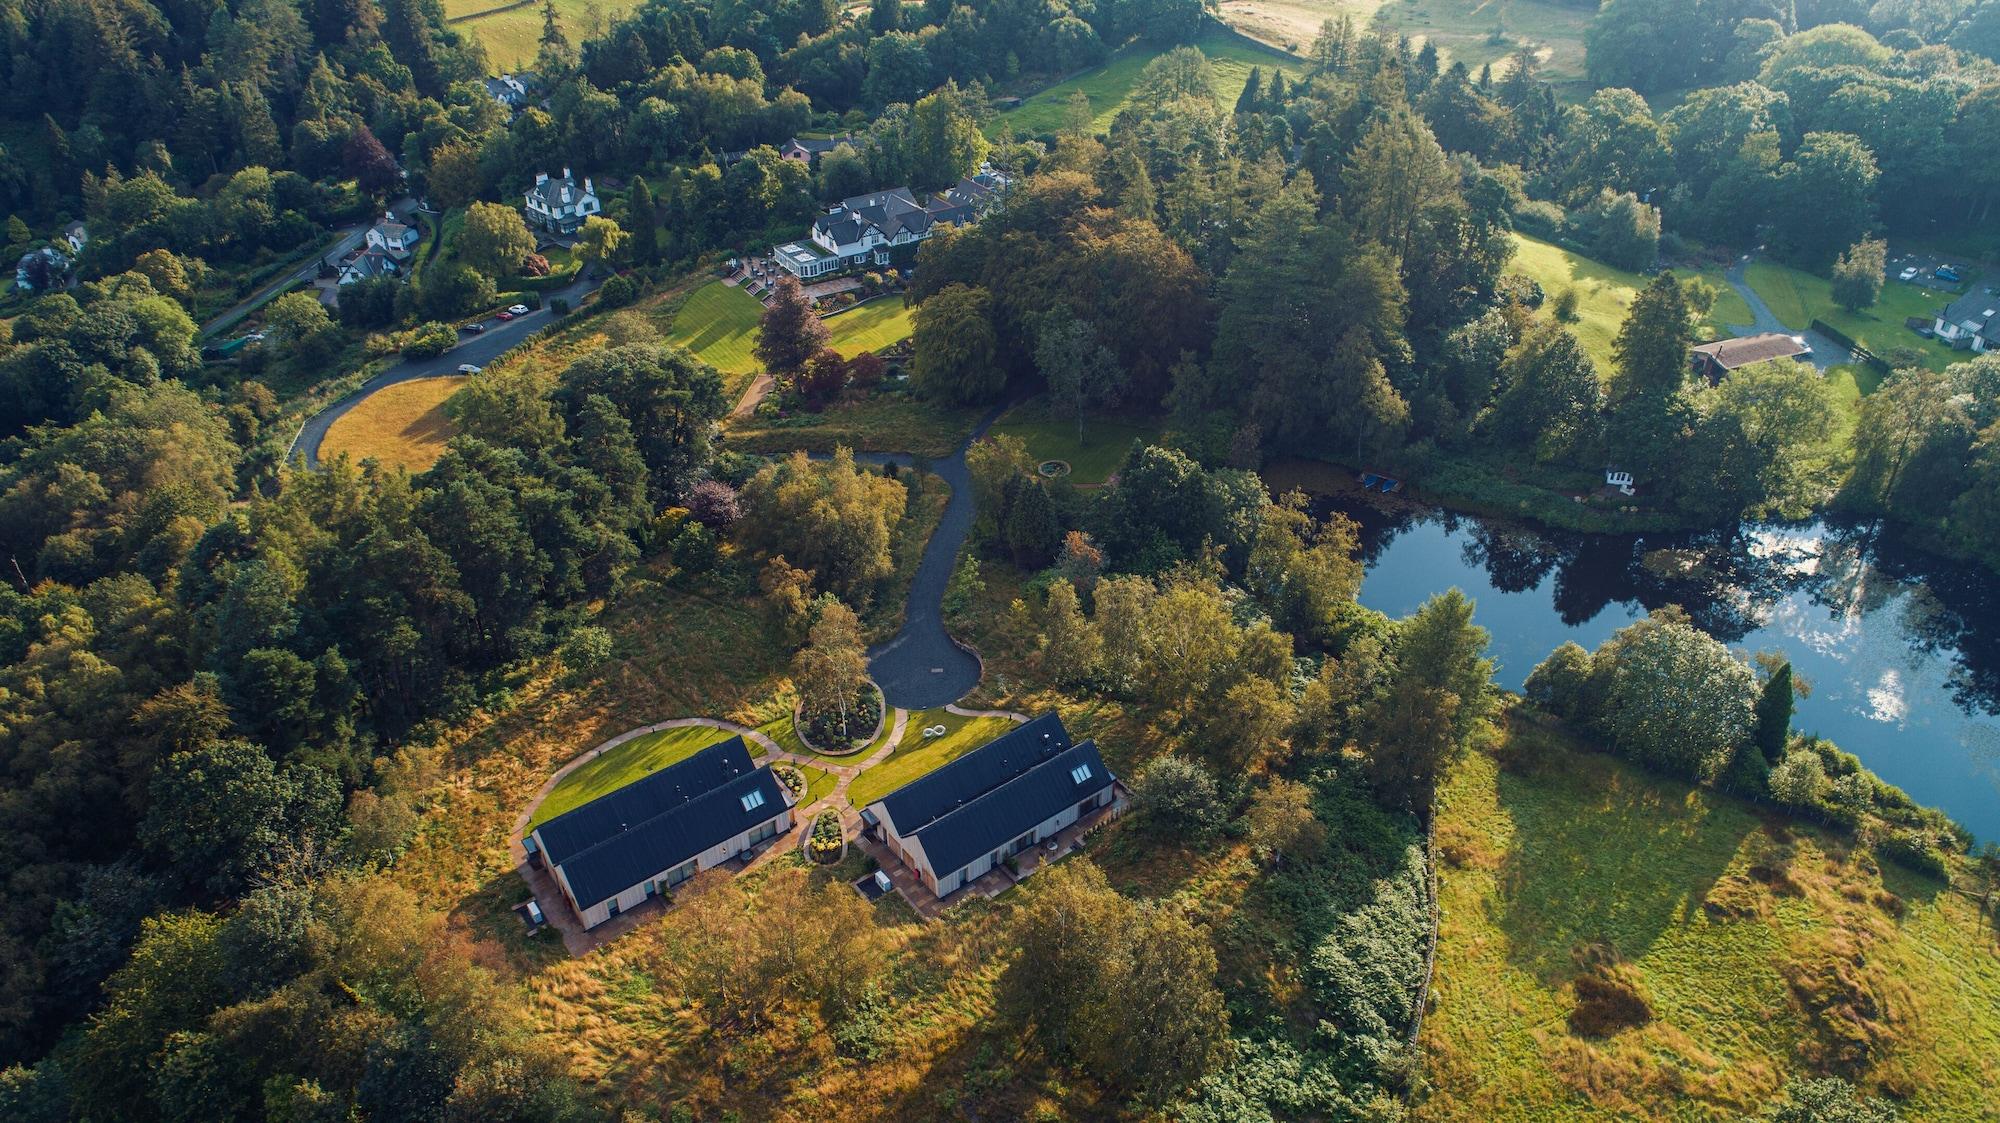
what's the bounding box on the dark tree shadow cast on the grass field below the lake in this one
[1498,753,1756,985]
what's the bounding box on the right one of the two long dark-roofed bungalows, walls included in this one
[862,713,1116,897]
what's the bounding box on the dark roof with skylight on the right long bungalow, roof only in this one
[880,713,1112,875]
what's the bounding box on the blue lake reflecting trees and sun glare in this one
[1316,485,2000,839]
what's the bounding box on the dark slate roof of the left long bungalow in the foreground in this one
[534,737,788,909]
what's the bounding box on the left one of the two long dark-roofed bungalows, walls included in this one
[522,737,792,929]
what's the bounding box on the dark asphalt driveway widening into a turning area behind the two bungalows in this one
[856,397,1006,709]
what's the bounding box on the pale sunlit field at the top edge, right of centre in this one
[1220,0,1594,84]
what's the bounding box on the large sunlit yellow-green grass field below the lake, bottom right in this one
[1416,715,2000,1123]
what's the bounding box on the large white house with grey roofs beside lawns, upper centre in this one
[772,168,1006,280]
